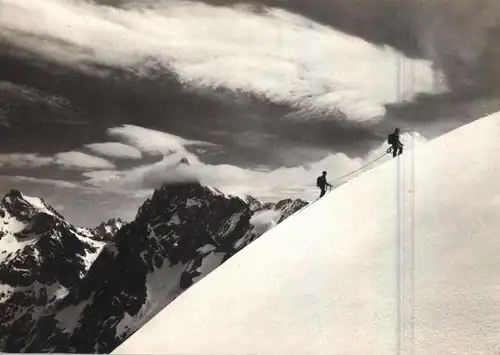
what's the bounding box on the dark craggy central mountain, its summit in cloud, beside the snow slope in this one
[0,183,307,353]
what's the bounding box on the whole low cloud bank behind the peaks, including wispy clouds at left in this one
[0,125,426,225]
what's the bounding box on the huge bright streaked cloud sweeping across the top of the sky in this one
[0,0,438,122]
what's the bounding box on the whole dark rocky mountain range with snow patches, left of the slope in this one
[0,183,307,353]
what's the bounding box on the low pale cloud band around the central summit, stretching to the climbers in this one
[80,132,426,201]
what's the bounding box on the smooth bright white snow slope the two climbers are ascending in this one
[114,113,500,355]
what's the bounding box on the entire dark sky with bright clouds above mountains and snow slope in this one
[0,0,500,225]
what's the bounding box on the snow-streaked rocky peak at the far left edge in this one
[0,190,104,349]
